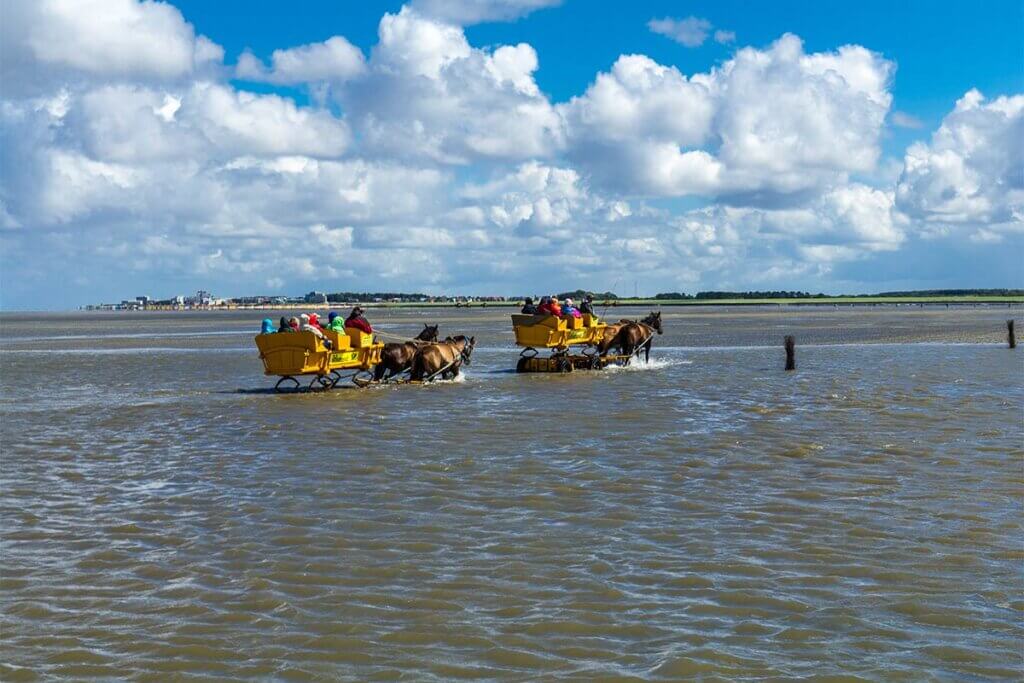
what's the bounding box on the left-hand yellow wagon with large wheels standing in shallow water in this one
[256,328,384,391]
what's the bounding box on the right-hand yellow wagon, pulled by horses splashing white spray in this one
[512,313,631,373]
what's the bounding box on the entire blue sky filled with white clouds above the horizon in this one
[0,0,1024,310]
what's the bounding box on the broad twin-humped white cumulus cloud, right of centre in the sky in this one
[561,35,893,203]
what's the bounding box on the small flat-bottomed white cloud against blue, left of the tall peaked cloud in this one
[236,36,366,85]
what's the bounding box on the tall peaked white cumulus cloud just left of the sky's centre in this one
[337,7,562,164]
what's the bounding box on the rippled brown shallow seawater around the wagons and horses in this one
[0,307,1024,681]
